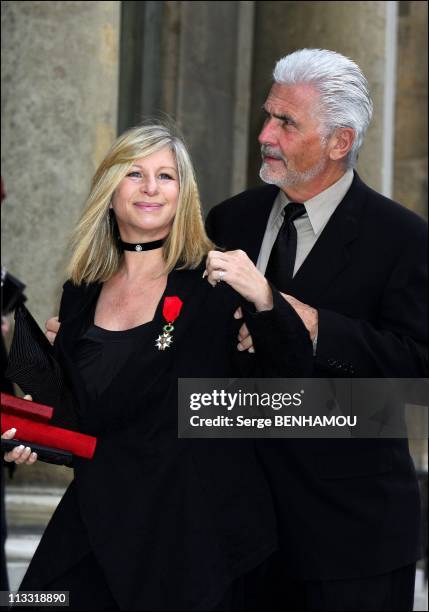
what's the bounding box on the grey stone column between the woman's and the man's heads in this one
[176,2,254,210]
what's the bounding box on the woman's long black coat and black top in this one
[19,270,312,610]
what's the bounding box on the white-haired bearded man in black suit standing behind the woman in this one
[207,49,427,610]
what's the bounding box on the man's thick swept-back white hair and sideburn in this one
[273,49,373,167]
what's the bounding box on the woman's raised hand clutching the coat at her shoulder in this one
[204,250,273,311]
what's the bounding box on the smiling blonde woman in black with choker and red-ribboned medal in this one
[5,125,312,610]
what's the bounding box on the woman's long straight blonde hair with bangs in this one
[67,123,214,285]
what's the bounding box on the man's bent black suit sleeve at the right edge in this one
[316,235,427,378]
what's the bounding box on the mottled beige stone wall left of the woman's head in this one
[1,1,120,484]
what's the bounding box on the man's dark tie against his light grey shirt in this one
[265,202,305,290]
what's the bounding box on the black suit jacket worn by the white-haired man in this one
[206,174,427,579]
